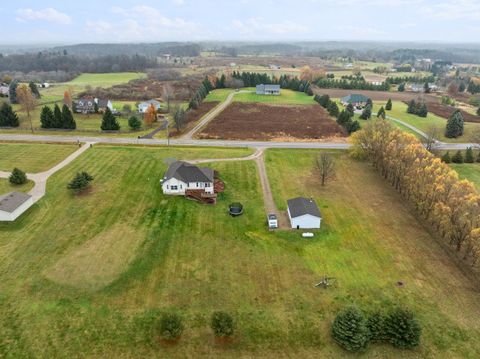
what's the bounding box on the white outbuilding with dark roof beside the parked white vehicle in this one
[288,197,322,229]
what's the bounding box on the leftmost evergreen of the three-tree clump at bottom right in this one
[332,307,370,352]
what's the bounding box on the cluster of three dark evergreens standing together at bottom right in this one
[332,307,422,352]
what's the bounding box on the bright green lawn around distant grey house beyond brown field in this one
[205,87,316,105]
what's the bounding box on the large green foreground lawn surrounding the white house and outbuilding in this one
[0,146,480,358]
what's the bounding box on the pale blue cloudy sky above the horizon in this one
[0,0,480,44]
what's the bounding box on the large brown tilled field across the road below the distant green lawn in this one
[198,102,346,141]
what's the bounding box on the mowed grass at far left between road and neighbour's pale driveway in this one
[0,143,78,173]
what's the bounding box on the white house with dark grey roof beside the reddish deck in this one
[161,161,215,196]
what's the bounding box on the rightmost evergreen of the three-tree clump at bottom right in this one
[385,308,422,349]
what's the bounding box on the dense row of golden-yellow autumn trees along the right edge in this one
[351,120,480,266]
